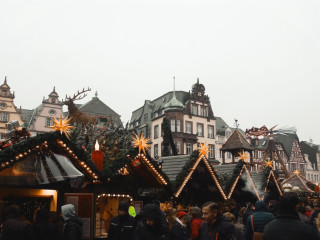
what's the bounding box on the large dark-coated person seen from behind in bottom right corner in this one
[263,193,319,240]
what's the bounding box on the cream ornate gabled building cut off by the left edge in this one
[0,77,23,141]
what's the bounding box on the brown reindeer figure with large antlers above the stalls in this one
[63,88,96,125]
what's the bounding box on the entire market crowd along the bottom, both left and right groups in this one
[0,193,320,240]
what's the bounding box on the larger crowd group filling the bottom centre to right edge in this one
[107,193,320,240]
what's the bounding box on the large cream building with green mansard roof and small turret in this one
[130,79,216,159]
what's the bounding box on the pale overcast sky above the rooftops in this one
[0,0,320,144]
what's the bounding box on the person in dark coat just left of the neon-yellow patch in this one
[107,201,134,240]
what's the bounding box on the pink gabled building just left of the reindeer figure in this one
[22,87,63,135]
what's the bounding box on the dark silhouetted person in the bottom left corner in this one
[0,205,34,240]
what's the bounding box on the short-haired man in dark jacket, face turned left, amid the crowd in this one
[200,202,235,240]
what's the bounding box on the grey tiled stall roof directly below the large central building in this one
[160,155,190,181]
